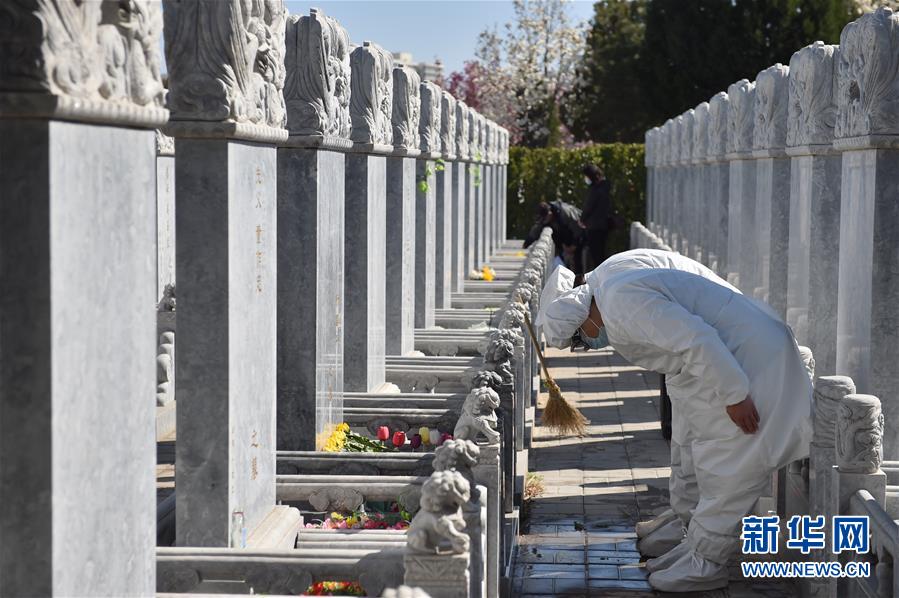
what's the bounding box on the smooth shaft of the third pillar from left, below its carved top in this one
[277,148,345,450]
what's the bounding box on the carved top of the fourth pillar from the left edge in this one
[350,42,393,151]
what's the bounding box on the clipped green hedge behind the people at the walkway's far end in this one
[508,143,646,253]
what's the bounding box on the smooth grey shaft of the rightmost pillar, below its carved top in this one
[836,149,899,459]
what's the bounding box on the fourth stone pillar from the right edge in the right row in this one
[727,79,758,293]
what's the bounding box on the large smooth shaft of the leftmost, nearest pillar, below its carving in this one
[0,119,158,596]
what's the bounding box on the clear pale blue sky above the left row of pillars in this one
[286,0,593,73]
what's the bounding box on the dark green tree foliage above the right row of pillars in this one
[563,0,859,142]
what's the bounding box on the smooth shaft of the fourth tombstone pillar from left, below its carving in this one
[343,154,387,392]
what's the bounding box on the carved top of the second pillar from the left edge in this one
[164,0,287,129]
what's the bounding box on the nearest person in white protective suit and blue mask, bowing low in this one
[536,250,812,592]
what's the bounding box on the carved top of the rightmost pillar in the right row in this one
[835,8,899,138]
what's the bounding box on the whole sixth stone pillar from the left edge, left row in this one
[415,81,442,328]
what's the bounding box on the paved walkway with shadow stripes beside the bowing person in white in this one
[513,349,796,598]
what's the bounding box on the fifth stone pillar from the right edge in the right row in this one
[705,92,730,277]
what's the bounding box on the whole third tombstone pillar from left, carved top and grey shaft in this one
[277,9,352,450]
